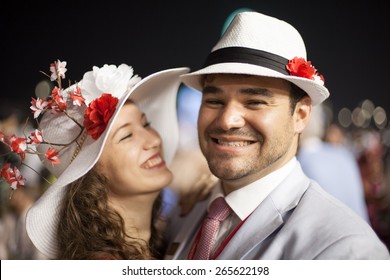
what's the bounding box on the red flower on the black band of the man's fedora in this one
[286,57,324,85]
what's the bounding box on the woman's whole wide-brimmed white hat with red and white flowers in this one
[0,60,189,258]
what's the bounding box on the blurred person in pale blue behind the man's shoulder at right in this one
[297,104,369,222]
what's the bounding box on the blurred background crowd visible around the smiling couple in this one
[0,85,390,259]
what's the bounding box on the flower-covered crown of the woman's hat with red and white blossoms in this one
[0,60,141,190]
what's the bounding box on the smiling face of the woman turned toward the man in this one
[97,102,173,198]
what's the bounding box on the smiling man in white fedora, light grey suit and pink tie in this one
[166,12,390,259]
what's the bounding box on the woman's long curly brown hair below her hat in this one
[57,169,161,260]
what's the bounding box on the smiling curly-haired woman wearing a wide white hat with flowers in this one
[2,61,189,259]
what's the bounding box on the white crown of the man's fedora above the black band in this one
[212,12,306,60]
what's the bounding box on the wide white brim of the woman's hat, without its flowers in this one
[26,67,189,259]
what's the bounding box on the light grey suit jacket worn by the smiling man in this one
[166,164,390,260]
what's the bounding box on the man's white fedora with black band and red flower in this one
[181,11,329,105]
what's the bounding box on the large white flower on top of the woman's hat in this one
[80,64,141,105]
